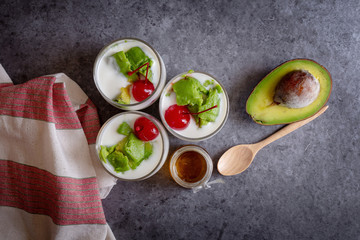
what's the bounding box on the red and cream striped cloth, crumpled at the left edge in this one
[0,65,116,240]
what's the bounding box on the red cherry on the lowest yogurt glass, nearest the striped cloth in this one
[134,117,159,141]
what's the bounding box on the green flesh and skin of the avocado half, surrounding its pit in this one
[246,59,332,125]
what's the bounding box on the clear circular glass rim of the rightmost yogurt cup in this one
[159,71,230,142]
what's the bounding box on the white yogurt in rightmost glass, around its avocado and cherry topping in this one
[159,71,229,142]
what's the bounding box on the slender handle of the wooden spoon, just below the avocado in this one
[257,106,328,149]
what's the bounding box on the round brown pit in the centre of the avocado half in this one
[274,70,320,108]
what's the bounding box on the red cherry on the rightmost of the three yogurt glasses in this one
[165,104,191,130]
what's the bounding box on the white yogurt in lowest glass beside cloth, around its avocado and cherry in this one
[96,111,169,181]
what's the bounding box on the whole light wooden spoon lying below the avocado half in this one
[217,106,328,176]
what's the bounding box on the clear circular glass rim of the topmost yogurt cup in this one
[93,37,164,110]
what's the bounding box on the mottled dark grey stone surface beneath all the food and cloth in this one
[0,0,360,239]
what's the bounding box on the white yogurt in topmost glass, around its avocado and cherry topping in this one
[93,38,166,110]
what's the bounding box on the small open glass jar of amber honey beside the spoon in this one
[169,145,213,189]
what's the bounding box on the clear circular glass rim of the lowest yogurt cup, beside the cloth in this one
[95,111,168,181]
